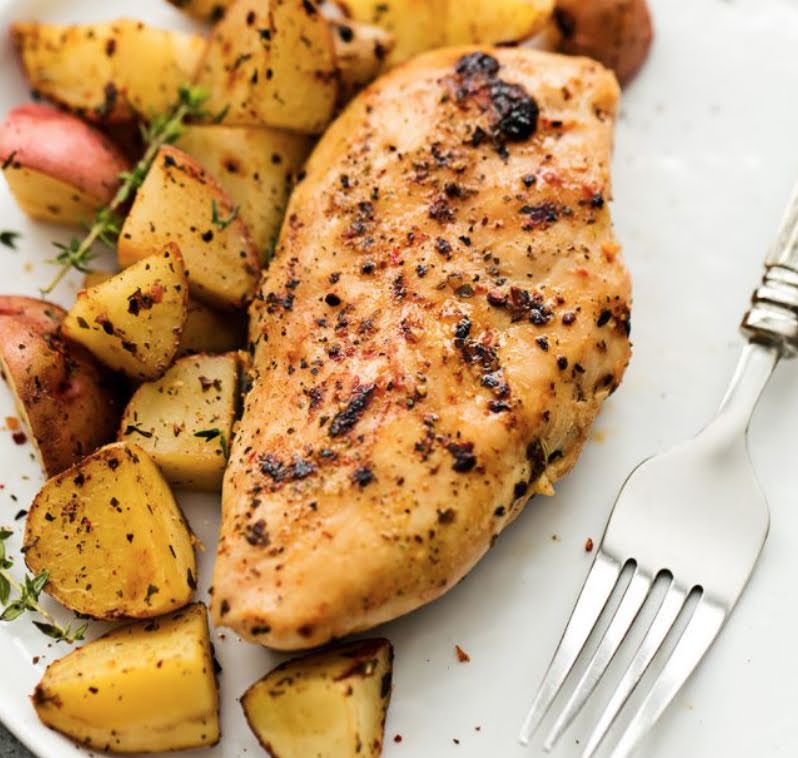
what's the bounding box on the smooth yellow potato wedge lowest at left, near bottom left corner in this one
[33,603,220,753]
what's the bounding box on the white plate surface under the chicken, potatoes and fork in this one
[0,0,798,758]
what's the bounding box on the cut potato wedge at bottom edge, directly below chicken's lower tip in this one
[241,639,393,758]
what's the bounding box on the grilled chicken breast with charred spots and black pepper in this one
[212,48,630,650]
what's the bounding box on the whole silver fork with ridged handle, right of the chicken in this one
[520,180,798,758]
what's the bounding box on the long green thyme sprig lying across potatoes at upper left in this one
[42,85,207,295]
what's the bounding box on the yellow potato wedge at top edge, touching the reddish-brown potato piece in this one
[446,0,552,45]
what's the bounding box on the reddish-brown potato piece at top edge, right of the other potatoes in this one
[554,0,654,84]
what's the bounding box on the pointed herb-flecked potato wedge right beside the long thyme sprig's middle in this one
[118,145,260,309]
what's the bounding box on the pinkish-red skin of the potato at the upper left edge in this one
[0,104,130,205]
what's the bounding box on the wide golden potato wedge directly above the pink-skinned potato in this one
[11,19,205,122]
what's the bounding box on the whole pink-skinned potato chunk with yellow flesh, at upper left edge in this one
[0,104,128,226]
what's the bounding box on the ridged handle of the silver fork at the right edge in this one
[740,181,798,358]
